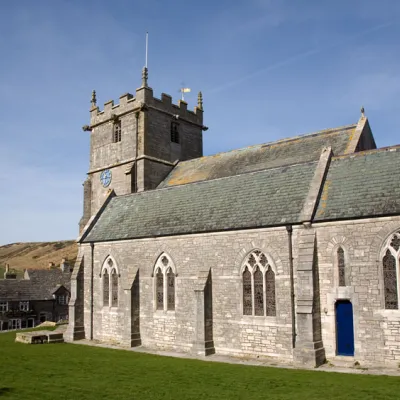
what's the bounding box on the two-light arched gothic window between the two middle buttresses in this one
[154,253,176,311]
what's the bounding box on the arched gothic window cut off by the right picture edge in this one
[382,231,400,310]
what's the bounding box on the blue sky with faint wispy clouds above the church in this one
[0,0,400,244]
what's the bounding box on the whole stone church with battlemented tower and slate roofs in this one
[65,69,400,365]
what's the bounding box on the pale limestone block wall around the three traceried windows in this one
[79,228,292,359]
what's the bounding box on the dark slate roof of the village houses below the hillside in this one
[0,268,71,301]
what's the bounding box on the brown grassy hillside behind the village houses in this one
[0,240,78,272]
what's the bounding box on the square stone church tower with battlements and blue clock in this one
[79,68,207,232]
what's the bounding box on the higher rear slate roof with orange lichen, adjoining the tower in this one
[158,125,357,188]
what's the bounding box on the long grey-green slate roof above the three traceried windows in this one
[83,162,317,242]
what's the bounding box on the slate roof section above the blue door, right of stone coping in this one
[315,146,400,221]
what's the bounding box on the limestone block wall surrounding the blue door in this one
[314,217,400,365]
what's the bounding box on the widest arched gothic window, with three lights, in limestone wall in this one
[242,250,276,317]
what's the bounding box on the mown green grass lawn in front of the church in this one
[0,332,400,400]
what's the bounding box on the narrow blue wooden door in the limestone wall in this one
[336,301,354,356]
